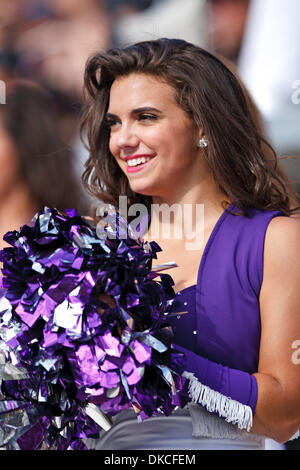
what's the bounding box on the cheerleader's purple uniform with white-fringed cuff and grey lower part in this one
[82,204,283,449]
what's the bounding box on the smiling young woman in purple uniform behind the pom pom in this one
[82,39,300,449]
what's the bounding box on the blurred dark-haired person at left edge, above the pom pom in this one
[0,81,88,252]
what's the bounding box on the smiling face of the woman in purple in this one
[106,74,201,198]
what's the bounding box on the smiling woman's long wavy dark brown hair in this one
[81,39,300,215]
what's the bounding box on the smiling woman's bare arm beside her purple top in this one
[252,217,300,442]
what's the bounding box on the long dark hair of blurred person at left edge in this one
[0,79,89,213]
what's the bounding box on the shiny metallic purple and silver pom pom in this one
[0,207,187,449]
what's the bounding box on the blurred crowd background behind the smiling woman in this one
[0,0,300,449]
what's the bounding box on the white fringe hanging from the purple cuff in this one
[182,372,253,432]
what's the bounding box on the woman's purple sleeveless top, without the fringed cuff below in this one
[169,204,284,374]
